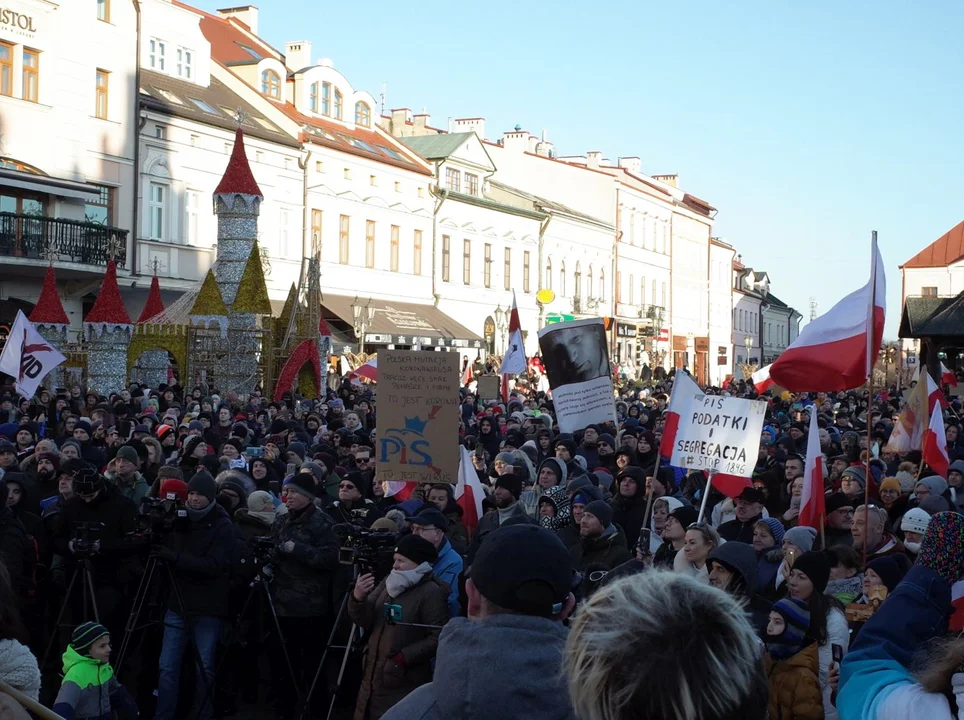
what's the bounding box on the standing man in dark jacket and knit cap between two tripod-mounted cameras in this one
[271,472,339,717]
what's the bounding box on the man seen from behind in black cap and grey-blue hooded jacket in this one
[382,524,575,720]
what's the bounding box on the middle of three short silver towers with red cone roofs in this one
[84,259,134,396]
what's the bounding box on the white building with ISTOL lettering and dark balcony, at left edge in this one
[0,0,137,330]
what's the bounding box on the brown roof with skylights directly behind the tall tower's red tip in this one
[140,69,301,148]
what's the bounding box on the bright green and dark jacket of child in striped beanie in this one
[53,645,137,720]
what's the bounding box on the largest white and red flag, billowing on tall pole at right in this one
[770,233,886,392]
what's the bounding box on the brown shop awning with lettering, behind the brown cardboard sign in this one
[321,293,485,349]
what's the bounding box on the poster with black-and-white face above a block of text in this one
[539,318,616,433]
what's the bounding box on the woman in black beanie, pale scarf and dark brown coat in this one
[348,535,449,720]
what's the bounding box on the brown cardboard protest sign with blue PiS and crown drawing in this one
[375,350,459,484]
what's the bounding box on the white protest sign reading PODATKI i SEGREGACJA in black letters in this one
[670,394,767,477]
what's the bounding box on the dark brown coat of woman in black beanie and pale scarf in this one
[348,574,449,720]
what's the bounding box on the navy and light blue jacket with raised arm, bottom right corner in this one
[837,565,964,720]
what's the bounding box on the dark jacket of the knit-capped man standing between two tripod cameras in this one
[271,505,339,617]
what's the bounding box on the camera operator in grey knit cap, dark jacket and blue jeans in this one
[154,469,235,720]
